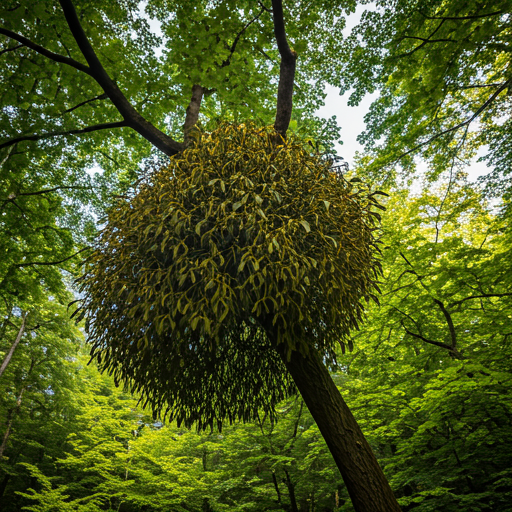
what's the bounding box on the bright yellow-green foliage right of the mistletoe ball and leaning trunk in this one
[343,181,512,512]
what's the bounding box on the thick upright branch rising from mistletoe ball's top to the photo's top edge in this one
[272,0,297,139]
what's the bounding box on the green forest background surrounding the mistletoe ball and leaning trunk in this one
[0,0,512,512]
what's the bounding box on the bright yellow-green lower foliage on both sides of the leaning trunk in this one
[0,180,512,512]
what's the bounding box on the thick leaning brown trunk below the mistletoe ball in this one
[276,344,400,512]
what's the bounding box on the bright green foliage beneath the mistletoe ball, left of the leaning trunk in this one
[14,368,341,512]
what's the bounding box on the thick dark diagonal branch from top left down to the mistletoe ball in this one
[59,0,185,156]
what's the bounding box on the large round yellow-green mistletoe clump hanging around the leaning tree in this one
[81,125,380,428]
